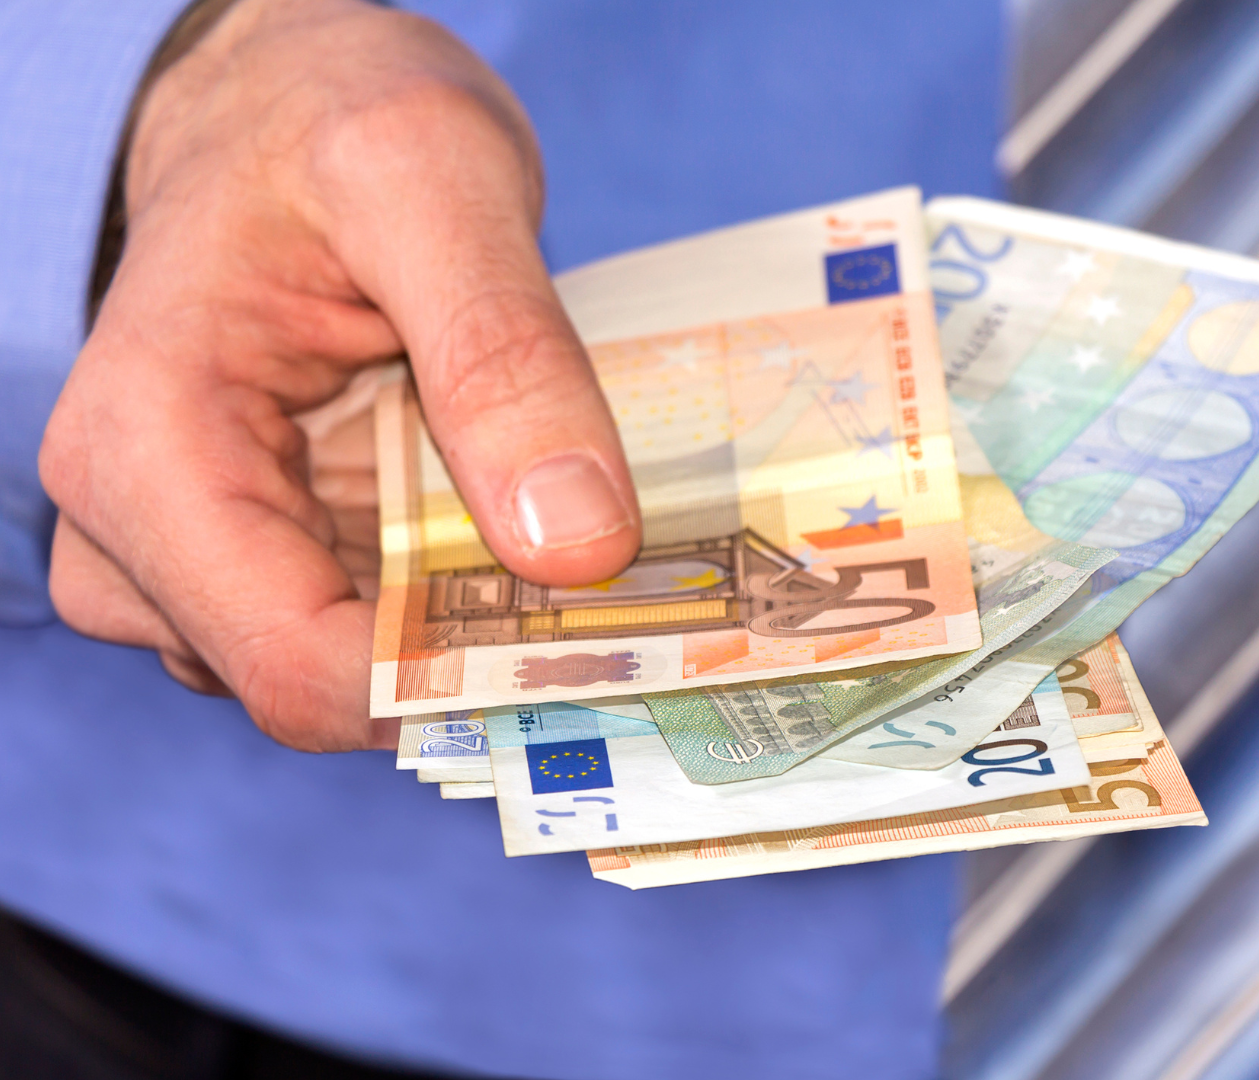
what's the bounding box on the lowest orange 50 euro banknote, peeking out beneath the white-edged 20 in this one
[588,638,1207,889]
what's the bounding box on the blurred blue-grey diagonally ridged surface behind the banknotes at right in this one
[944,0,1259,1080]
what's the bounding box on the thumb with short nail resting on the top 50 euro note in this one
[322,91,642,585]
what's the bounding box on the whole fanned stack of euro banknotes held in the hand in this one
[371,189,1259,889]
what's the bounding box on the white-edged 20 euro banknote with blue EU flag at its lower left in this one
[486,677,1088,856]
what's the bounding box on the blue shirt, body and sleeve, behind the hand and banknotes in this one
[0,0,1000,1080]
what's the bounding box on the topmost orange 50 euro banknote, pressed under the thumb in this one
[371,189,981,716]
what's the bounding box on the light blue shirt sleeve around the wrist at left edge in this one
[0,0,185,626]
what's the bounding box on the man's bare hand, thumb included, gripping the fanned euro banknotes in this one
[40,0,641,749]
